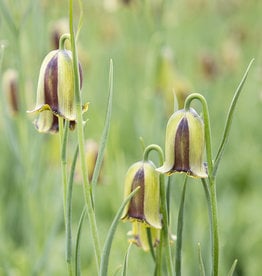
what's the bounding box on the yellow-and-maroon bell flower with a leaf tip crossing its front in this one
[122,161,161,229]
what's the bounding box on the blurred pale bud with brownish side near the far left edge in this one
[3,69,19,115]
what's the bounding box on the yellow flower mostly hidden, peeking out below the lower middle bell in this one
[127,221,161,251]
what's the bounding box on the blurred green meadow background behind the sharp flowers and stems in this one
[0,0,262,276]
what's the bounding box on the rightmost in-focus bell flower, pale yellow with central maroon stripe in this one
[157,108,207,178]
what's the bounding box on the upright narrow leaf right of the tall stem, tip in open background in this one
[92,59,113,186]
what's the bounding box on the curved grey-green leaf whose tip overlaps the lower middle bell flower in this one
[99,187,140,276]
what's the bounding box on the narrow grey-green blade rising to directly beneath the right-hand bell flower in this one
[175,176,187,276]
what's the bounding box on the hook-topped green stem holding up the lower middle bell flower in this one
[143,144,174,275]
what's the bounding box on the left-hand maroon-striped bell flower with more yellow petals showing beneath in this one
[29,49,82,132]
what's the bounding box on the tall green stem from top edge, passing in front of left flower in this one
[69,0,101,271]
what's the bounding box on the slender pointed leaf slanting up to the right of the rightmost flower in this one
[213,59,254,176]
